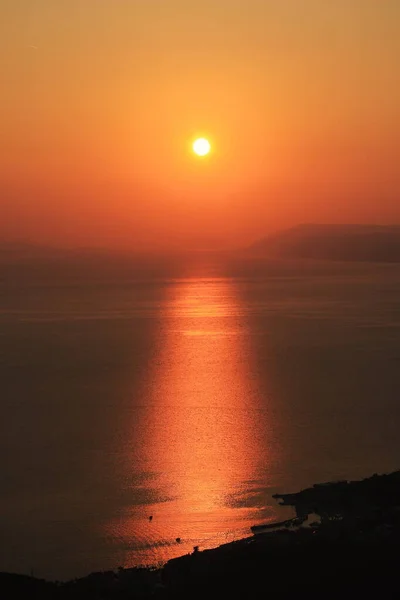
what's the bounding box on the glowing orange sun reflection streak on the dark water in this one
[112,278,282,566]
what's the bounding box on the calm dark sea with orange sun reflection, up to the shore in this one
[0,265,400,579]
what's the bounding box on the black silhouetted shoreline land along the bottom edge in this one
[0,471,400,600]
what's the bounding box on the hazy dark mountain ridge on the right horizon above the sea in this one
[249,224,400,262]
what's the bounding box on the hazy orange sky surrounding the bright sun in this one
[0,0,400,248]
